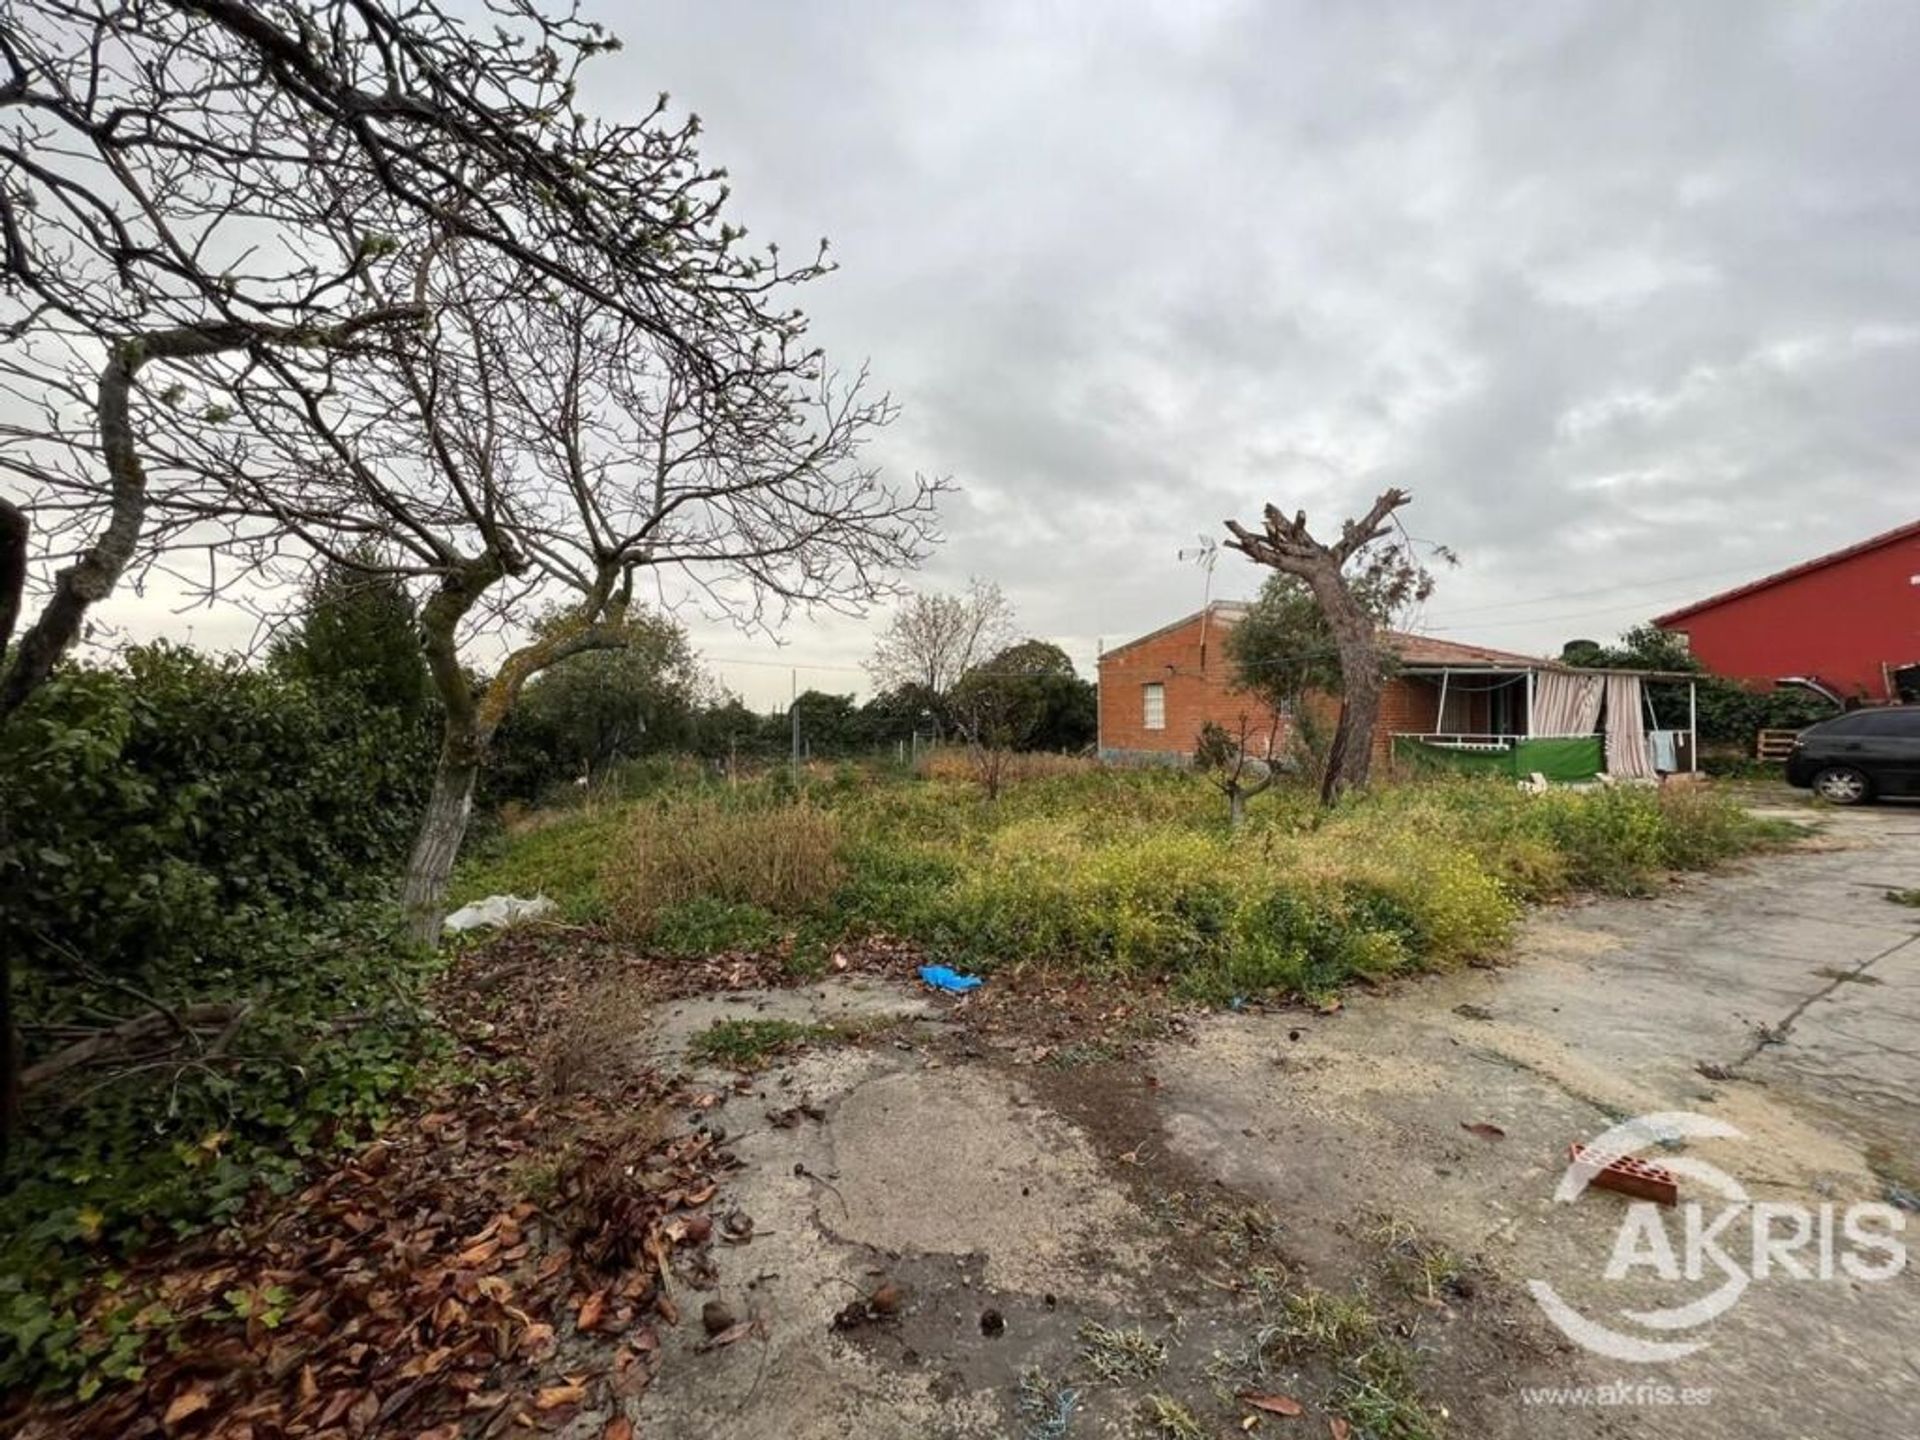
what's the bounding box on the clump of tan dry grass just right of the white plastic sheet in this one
[601,797,845,939]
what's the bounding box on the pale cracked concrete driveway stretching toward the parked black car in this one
[1154,810,1920,1440]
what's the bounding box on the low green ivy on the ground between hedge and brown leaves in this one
[0,906,438,1394]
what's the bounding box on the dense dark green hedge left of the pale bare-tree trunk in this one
[0,645,432,990]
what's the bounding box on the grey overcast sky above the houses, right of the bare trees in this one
[97,0,1920,703]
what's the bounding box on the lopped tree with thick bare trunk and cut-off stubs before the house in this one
[1227,490,1432,804]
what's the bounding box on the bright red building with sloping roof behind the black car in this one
[1653,520,1920,701]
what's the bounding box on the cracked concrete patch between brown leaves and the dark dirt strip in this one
[636,1029,1148,1440]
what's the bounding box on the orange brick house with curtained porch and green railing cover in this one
[1100,601,1693,780]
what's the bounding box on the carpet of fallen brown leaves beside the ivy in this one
[0,937,733,1440]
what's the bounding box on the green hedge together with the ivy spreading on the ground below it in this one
[0,647,432,1390]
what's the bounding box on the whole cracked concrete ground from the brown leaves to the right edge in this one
[622,806,1920,1440]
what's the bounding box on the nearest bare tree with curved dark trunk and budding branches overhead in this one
[0,0,822,720]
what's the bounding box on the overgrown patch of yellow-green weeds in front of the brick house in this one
[472,762,1780,1000]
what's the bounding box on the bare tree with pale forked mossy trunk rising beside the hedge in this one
[182,234,943,941]
